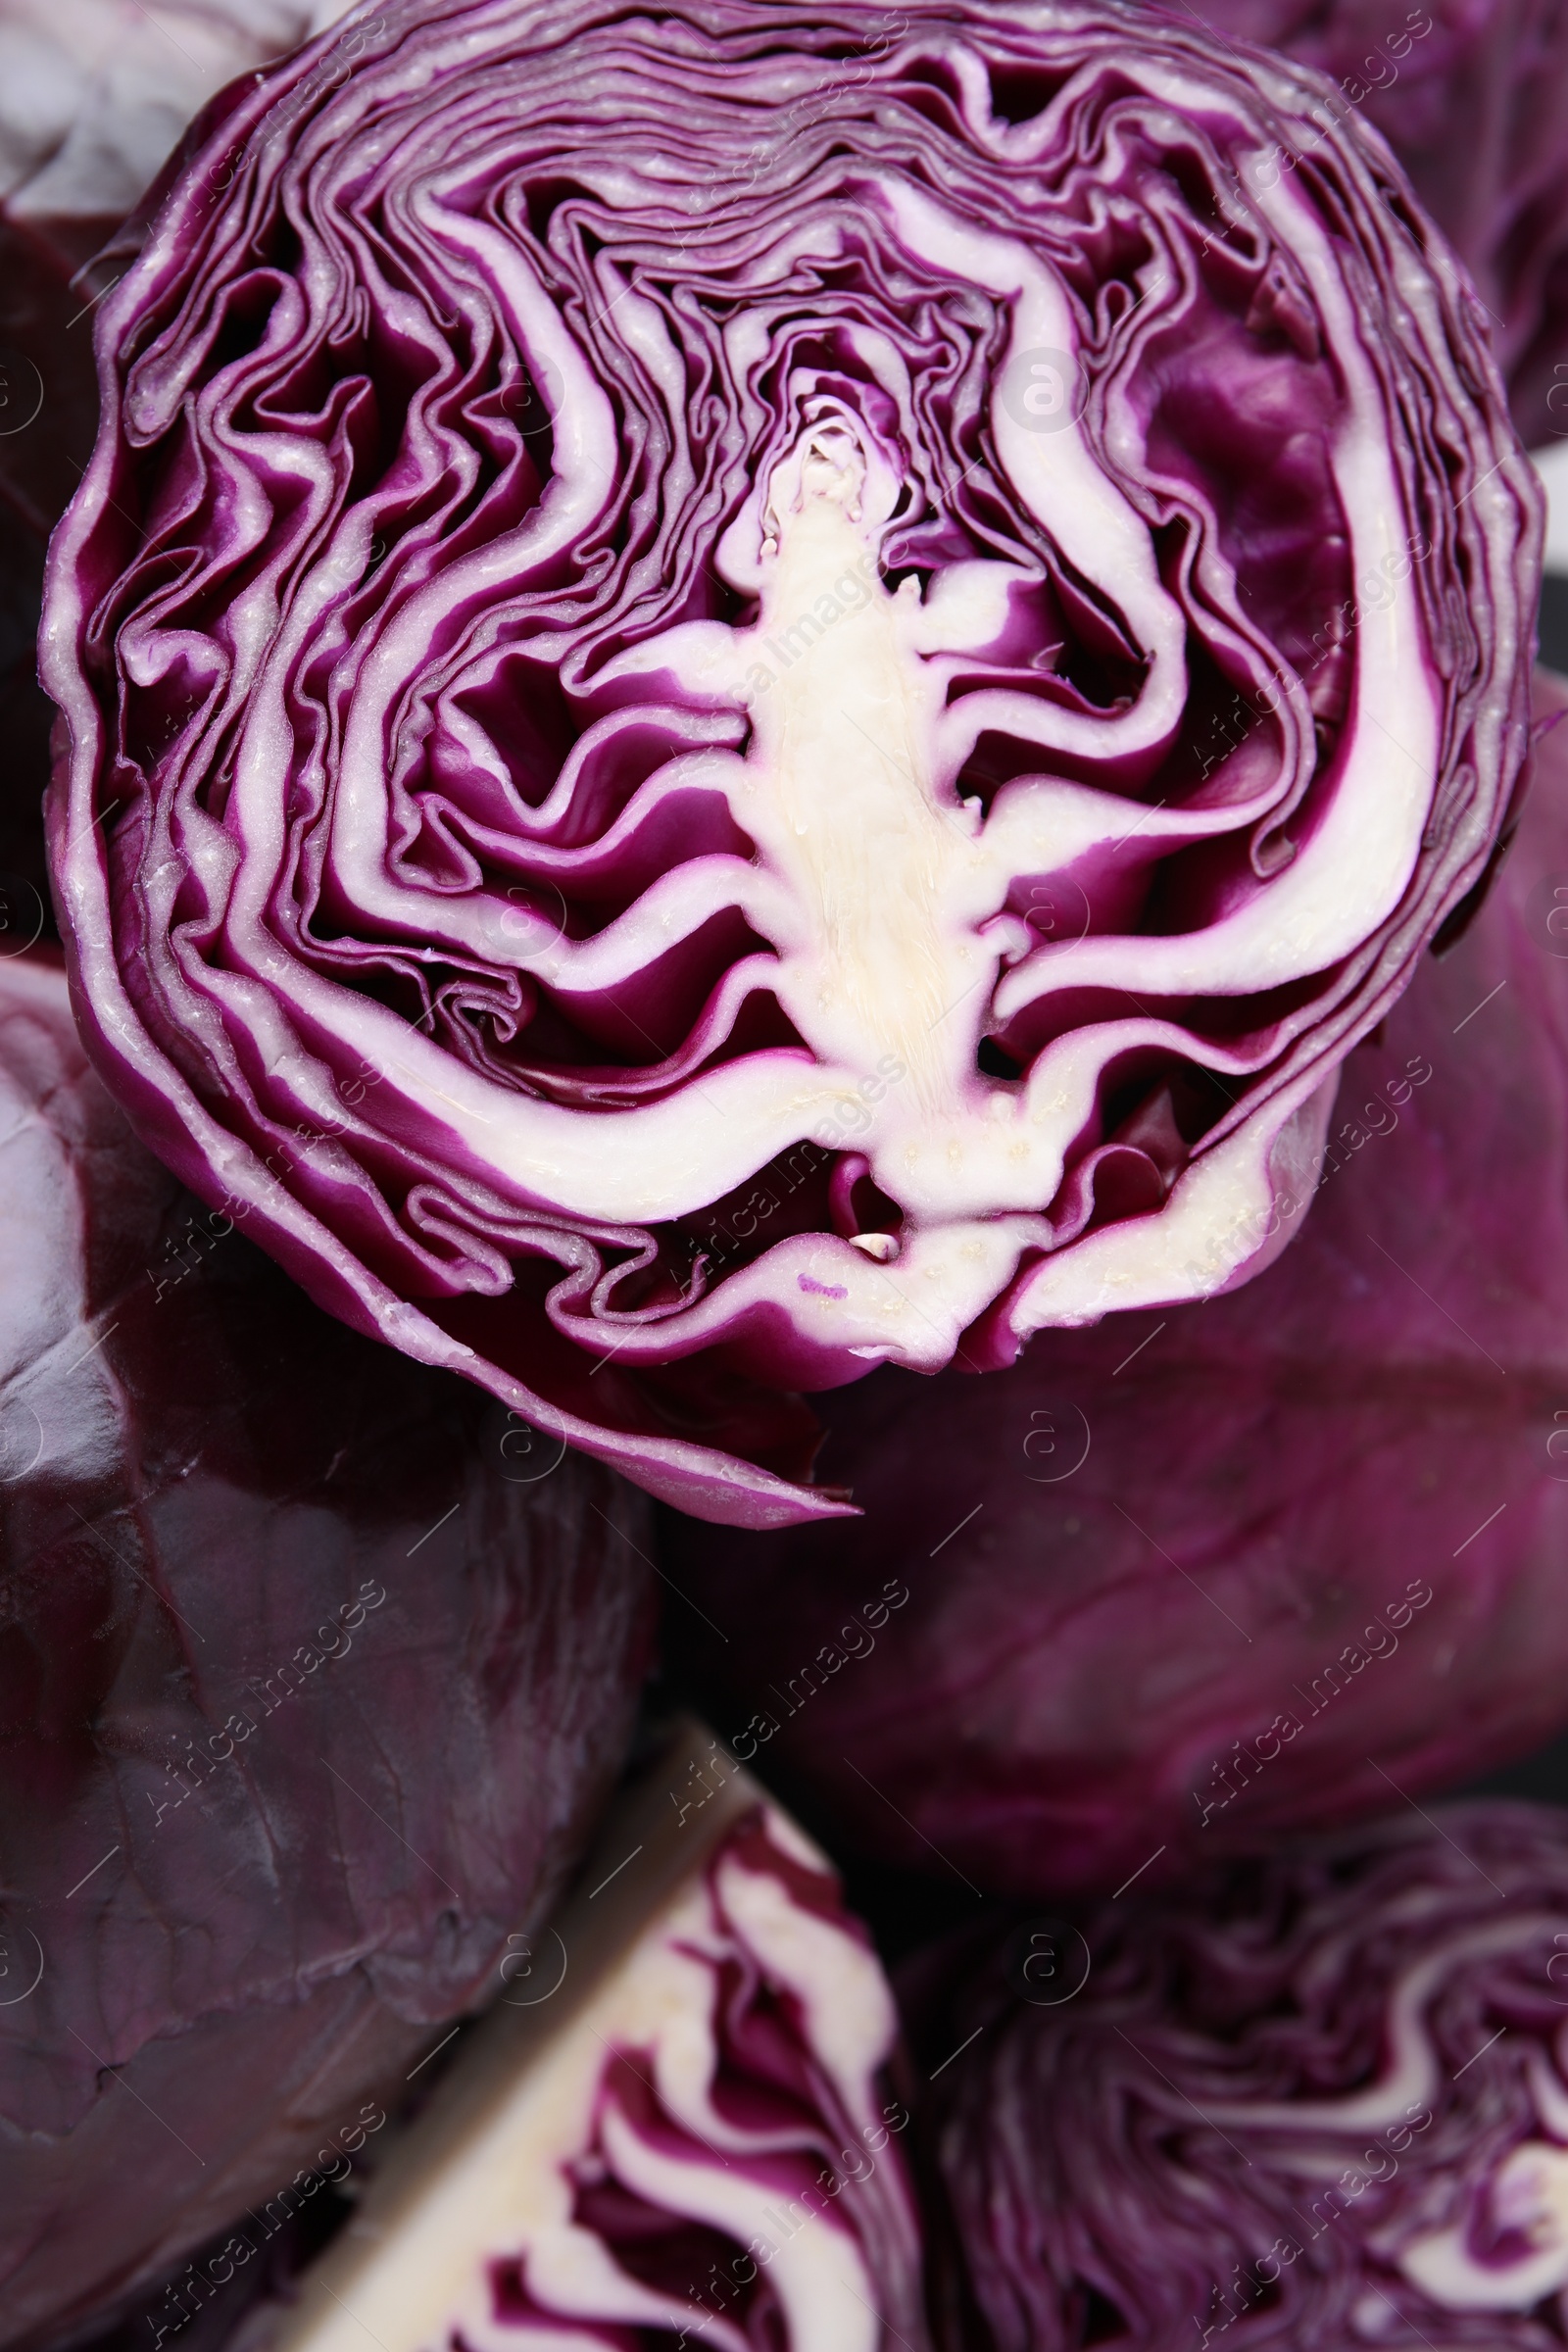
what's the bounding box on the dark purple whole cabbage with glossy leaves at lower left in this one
[0,957,651,2347]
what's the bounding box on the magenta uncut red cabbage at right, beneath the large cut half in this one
[667,680,1568,1893]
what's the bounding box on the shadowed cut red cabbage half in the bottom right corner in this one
[919,1804,1568,2352]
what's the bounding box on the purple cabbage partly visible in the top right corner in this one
[1168,0,1568,447]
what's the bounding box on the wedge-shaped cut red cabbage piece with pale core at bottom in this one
[261,1727,926,2352]
